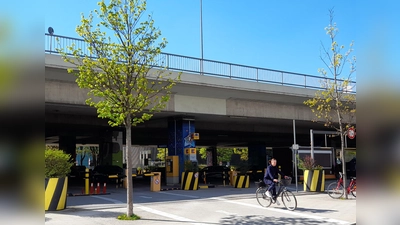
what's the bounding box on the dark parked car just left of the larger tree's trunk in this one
[92,165,126,183]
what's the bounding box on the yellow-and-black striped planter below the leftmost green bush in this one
[44,177,68,211]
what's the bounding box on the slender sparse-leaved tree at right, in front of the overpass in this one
[304,9,356,198]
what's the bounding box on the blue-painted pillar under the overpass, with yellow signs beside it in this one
[168,118,197,180]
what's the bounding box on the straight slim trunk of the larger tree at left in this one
[125,114,133,217]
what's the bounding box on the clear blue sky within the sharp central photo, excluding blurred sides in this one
[44,0,358,75]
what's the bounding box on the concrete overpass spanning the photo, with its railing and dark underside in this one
[45,35,356,174]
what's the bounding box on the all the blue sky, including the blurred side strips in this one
[0,0,400,84]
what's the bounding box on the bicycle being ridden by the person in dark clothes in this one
[256,178,297,211]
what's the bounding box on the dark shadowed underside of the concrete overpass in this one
[46,103,355,147]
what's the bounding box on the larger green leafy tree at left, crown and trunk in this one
[60,0,180,216]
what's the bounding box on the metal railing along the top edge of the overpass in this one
[45,33,356,94]
